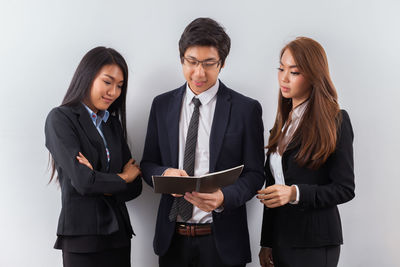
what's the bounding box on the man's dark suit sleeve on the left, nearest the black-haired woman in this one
[140,99,169,187]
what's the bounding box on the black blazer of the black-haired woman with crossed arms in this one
[45,104,142,236]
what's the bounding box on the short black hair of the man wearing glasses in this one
[179,18,231,66]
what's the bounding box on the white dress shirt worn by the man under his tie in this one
[177,80,219,223]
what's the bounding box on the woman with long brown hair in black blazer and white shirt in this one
[257,37,355,267]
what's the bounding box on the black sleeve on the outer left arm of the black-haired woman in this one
[45,108,127,195]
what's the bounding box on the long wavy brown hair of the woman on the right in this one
[267,37,341,169]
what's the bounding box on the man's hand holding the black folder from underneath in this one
[185,189,224,212]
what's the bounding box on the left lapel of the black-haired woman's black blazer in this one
[74,104,107,171]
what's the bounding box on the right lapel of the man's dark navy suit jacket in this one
[210,82,231,172]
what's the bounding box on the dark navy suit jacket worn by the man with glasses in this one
[141,82,265,265]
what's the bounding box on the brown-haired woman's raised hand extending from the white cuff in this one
[257,184,297,208]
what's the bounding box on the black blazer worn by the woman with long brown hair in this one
[261,110,355,247]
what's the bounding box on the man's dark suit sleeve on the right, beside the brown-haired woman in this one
[221,101,265,210]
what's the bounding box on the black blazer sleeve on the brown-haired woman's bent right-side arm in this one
[298,110,355,208]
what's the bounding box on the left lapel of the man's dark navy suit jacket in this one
[167,84,186,168]
